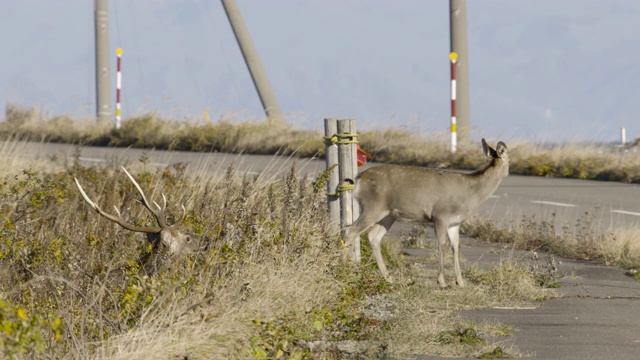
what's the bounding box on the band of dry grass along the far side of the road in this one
[5,105,640,183]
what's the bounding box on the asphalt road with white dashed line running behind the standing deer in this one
[5,142,640,232]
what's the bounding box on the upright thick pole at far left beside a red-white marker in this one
[94,0,111,124]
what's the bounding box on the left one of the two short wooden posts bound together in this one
[324,119,340,233]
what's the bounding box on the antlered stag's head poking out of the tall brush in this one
[74,167,201,275]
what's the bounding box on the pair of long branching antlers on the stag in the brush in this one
[74,167,187,233]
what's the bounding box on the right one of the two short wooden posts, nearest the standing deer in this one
[337,119,360,263]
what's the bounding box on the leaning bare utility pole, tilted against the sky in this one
[222,0,284,125]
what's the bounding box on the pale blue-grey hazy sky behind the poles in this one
[0,0,640,142]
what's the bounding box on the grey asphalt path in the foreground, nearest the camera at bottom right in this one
[408,237,640,360]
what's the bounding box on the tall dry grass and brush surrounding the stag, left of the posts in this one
[0,154,356,359]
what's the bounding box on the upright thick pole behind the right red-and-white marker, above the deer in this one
[449,0,471,143]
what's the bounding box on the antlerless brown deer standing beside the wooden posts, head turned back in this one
[344,139,509,288]
